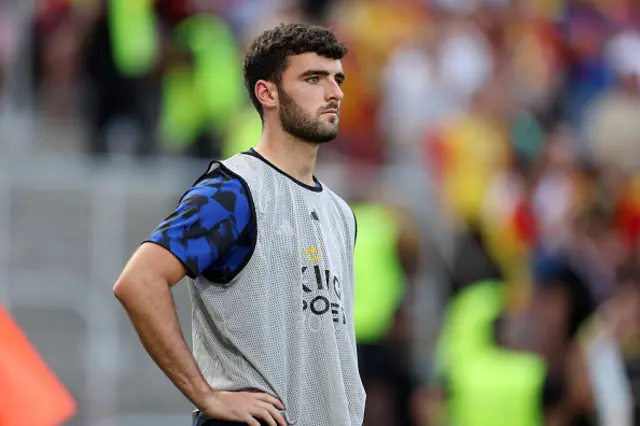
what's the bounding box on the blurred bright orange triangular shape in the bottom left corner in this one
[0,306,76,426]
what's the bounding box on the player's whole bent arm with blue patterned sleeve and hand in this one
[113,169,286,426]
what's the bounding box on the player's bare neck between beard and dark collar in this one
[255,125,318,186]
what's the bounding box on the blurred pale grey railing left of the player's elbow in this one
[0,151,202,426]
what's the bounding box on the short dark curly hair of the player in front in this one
[244,23,347,117]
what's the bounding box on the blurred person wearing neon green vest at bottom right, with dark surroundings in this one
[418,277,561,426]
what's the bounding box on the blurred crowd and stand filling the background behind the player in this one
[0,0,640,426]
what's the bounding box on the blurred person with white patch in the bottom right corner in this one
[567,258,640,425]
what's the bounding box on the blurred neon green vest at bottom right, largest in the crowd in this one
[437,281,546,426]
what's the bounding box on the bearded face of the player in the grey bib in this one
[278,53,344,144]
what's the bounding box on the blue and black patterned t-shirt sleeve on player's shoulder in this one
[147,170,251,278]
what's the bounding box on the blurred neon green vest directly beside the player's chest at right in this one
[353,204,405,343]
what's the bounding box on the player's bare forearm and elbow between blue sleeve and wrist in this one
[113,243,213,407]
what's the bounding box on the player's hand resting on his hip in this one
[200,392,287,426]
